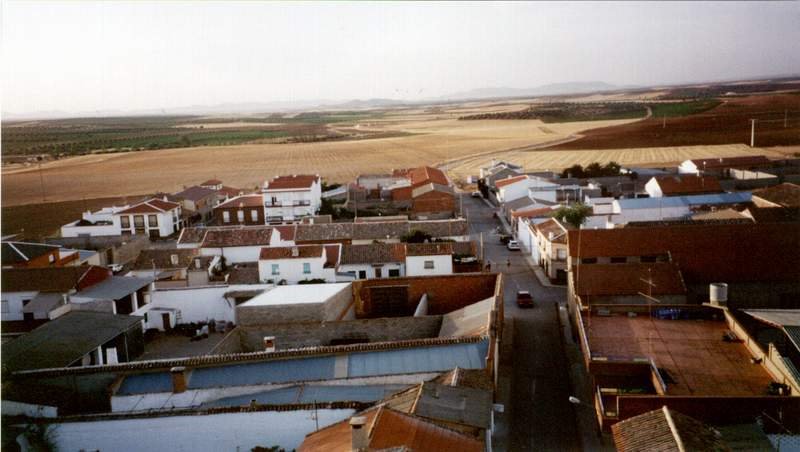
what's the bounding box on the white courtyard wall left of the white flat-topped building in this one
[149,284,273,323]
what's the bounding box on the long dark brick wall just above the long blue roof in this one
[233,315,442,353]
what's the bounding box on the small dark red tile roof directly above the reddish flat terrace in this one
[573,262,686,297]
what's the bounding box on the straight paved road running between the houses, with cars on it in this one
[462,194,581,451]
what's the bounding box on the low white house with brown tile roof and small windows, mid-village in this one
[258,244,341,284]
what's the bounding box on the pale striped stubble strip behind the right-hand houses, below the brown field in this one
[449,145,800,178]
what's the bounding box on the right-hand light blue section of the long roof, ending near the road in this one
[348,340,489,378]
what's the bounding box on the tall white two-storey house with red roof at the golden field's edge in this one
[262,175,322,222]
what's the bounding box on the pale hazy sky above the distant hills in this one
[2,1,800,113]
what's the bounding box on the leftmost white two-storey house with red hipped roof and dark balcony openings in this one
[113,198,182,237]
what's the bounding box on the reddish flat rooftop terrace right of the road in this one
[583,314,773,396]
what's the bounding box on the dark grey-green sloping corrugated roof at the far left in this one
[2,311,142,372]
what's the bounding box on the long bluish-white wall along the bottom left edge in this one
[48,409,355,452]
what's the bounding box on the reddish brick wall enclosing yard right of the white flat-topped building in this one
[353,273,498,318]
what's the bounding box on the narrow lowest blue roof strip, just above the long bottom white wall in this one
[202,385,408,408]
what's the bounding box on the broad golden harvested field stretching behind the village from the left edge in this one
[2,116,631,206]
